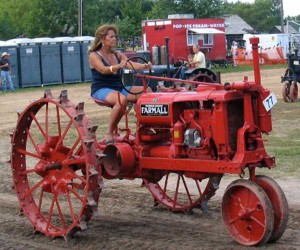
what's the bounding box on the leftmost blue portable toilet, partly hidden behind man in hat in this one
[0,41,20,89]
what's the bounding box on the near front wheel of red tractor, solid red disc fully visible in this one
[222,179,274,246]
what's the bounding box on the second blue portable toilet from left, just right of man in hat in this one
[9,38,42,88]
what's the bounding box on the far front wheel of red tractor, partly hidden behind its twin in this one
[255,175,289,242]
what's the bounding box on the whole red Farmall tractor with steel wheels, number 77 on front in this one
[11,38,288,246]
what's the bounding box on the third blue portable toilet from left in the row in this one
[32,37,62,85]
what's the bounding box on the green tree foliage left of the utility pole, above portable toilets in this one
[1,0,77,37]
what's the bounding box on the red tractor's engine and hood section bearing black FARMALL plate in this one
[137,91,244,160]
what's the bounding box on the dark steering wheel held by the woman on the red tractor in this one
[120,56,152,95]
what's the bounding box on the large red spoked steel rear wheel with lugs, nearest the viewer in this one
[11,92,101,237]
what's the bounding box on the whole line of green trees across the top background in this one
[0,0,300,40]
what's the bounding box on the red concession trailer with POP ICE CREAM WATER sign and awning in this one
[142,18,226,64]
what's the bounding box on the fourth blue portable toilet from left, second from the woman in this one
[54,37,82,83]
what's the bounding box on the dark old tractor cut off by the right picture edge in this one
[281,49,300,102]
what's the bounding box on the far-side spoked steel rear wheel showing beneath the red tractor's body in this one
[144,173,222,212]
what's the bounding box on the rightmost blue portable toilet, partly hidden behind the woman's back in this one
[74,36,95,82]
